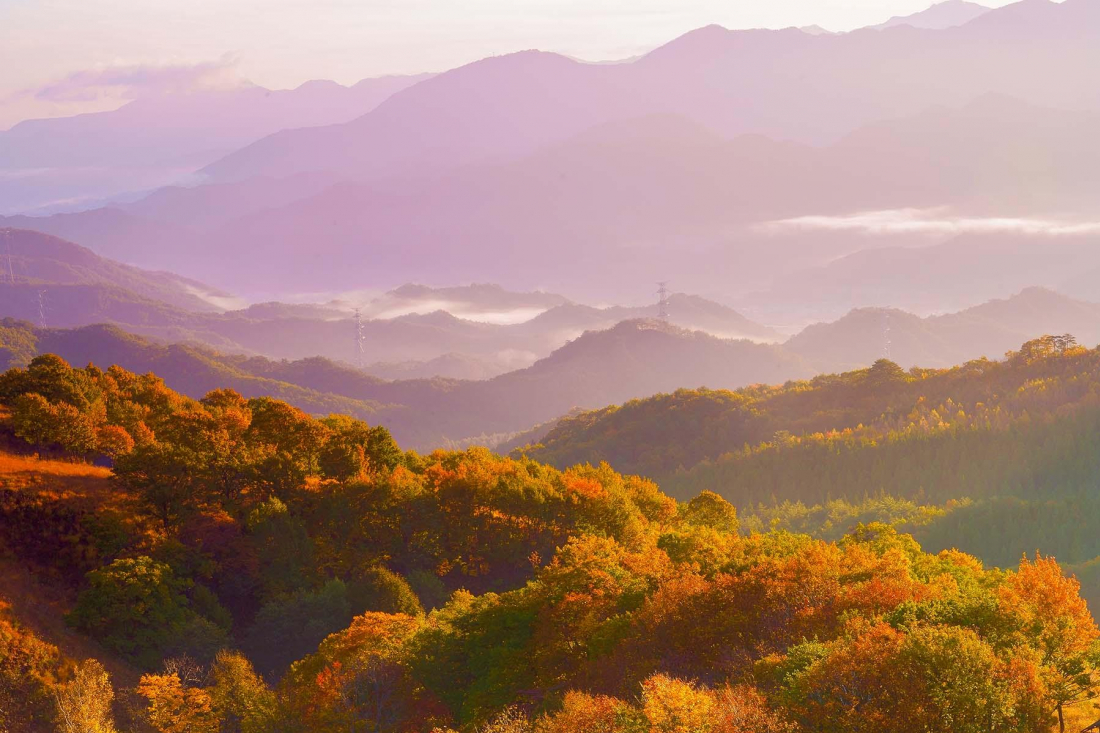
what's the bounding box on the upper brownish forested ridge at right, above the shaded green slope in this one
[520,337,1100,493]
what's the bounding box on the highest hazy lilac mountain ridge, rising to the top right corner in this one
[206,0,1100,188]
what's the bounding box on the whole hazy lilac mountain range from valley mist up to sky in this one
[8,0,1100,307]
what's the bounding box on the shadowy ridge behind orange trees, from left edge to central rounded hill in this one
[0,319,811,449]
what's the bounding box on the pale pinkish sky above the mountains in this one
[0,0,1029,130]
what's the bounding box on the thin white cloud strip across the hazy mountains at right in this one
[757,209,1100,237]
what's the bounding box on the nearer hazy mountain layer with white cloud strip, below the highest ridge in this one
[11,89,1100,305]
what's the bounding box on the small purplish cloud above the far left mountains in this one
[13,54,241,102]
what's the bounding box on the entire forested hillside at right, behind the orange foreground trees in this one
[517,337,1100,589]
